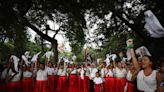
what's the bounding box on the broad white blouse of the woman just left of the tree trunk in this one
[36,69,48,80]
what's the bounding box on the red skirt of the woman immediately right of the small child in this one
[104,77,115,92]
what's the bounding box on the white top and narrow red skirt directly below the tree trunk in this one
[46,67,55,92]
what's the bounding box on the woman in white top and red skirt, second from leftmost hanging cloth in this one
[22,64,34,92]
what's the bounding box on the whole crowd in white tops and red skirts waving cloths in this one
[0,39,164,92]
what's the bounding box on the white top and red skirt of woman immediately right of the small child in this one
[104,69,115,92]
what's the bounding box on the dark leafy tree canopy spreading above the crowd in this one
[0,0,164,62]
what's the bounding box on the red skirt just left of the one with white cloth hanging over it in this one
[68,75,78,92]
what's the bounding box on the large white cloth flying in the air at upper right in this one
[144,10,164,38]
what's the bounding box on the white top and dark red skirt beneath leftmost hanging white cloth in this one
[8,70,22,92]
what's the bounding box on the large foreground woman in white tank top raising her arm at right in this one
[127,39,160,92]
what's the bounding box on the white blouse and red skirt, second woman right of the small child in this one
[115,67,126,92]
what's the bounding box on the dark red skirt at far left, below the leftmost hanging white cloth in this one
[8,81,22,92]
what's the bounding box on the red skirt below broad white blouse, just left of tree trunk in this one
[34,80,49,92]
